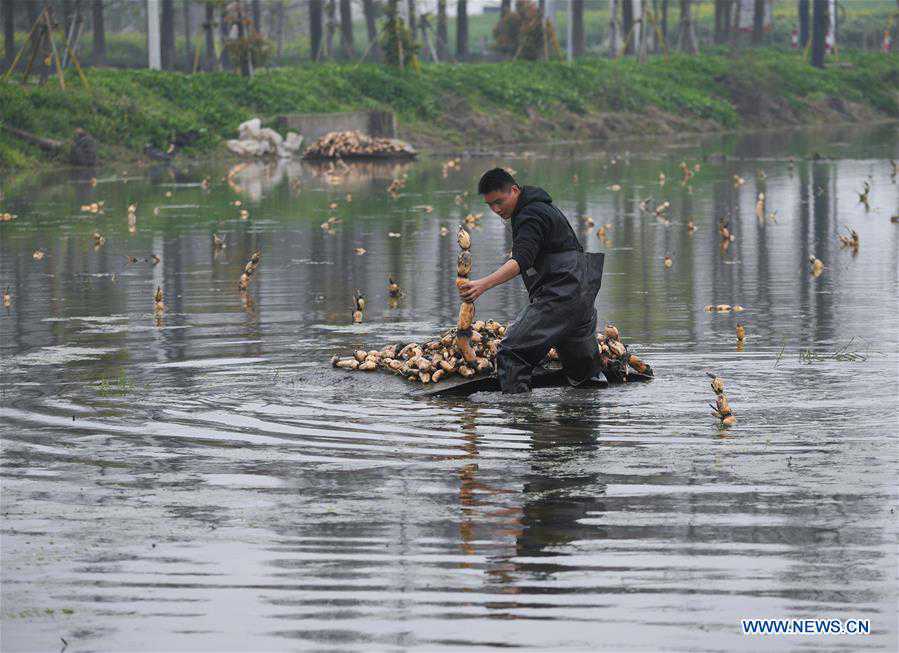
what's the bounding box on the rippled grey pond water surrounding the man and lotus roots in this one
[0,126,899,651]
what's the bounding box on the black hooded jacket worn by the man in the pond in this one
[512,186,584,296]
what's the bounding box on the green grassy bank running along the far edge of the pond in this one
[0,50,899,169]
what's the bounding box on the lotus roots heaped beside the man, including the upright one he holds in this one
[331,227,652,383]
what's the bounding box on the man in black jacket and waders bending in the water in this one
[459,168,605,393]
